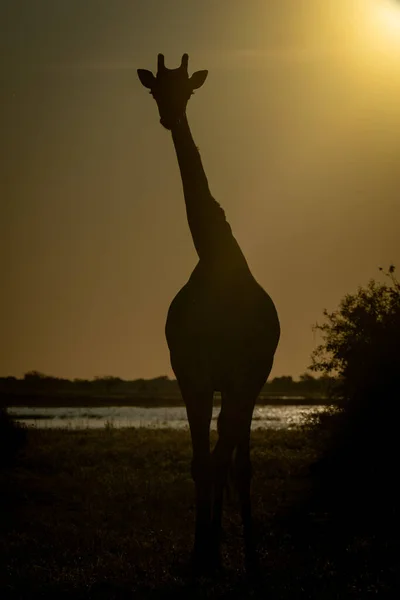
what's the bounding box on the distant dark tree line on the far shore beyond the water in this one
[0,371,334,398]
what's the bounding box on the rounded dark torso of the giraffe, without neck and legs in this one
[166,260,279,392]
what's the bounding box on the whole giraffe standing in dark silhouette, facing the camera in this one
[138,54,280,572]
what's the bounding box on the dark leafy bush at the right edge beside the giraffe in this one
[311,266,400,519]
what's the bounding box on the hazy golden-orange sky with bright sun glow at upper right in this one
[0,0,400,379]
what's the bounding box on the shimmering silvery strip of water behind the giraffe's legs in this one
[8,406,324,429]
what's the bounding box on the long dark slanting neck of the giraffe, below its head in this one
[171,115,247,266]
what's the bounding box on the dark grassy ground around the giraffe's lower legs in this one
[0,428,396,600]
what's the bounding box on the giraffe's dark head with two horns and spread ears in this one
[137,54,208,129]
